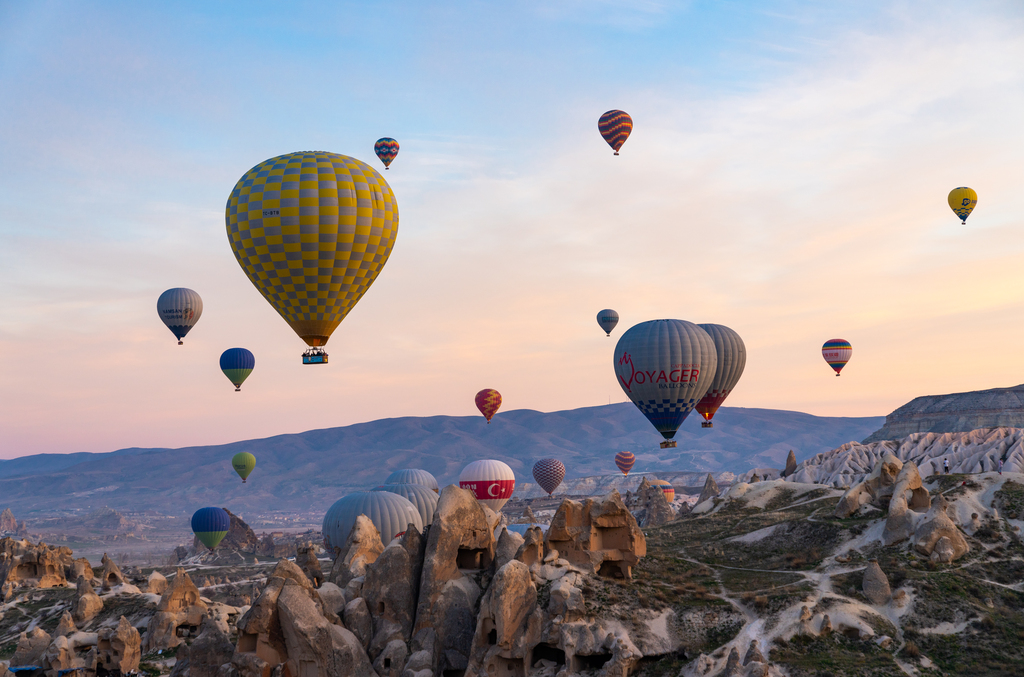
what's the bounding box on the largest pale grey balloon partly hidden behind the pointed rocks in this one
[323,492,423,552]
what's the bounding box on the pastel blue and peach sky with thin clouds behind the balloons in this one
[0,0,1024,458]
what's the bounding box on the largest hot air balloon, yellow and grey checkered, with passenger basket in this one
[225,151,398,365]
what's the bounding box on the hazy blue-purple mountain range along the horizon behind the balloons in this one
[0,403,884,518]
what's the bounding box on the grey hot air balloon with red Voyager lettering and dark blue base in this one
[613,320,718,449]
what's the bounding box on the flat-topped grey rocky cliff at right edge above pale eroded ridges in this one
[864,385,1024,445]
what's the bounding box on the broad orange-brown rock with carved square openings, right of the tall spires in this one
[545,487,647,580]
